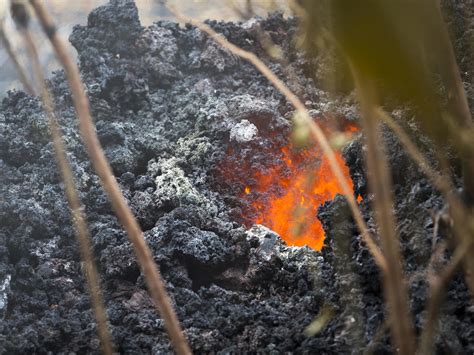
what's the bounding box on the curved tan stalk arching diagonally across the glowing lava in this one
[162,2,387,272]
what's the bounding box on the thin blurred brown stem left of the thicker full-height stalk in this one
[21,21,113,355]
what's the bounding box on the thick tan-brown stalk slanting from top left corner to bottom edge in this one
[30,0,191,354]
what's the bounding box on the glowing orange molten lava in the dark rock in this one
[244,122,361,250]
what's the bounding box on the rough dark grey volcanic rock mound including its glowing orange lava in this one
[0,0,474,355]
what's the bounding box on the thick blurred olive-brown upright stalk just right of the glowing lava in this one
[351,68,415,354]
